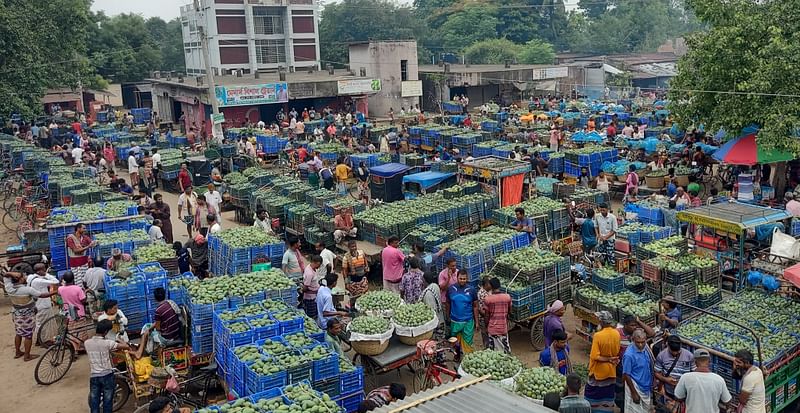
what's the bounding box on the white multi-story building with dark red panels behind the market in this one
[181,0,320,75]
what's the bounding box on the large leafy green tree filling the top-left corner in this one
[0,0,91,117]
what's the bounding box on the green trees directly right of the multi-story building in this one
[319,0,421,67]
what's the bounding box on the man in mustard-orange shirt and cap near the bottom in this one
[585,311,620,412]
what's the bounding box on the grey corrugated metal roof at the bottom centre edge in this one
[374,379,553,413]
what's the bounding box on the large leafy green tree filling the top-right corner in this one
[670,0,800,155]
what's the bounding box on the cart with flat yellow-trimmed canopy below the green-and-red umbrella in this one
[678,202,791,291]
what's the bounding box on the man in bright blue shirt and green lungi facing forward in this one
[444,269,478,353]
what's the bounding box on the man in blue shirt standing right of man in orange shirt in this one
[622,328,655,413]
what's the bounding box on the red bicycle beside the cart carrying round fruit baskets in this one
[414,337,461,391]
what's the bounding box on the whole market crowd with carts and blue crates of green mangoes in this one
[0,96,800,413]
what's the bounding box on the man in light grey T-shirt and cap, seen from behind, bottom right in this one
[675,348,732,413]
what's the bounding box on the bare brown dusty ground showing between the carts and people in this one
[0,169,589,413]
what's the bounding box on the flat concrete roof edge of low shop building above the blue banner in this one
[147,69,367,89]
